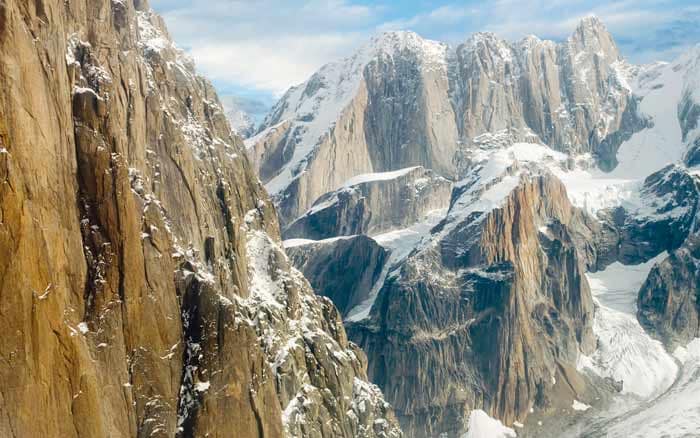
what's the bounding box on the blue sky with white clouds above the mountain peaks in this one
[150,0,700,113]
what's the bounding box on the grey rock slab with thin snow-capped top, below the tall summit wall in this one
[283,167,452,240]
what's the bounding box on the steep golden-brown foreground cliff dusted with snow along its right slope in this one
[0,0,401,437]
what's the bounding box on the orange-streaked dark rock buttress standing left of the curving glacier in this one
[349,173,595,437]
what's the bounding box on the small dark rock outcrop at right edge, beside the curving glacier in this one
[637,236,700,349]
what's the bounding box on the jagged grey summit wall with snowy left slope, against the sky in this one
[248,17,650,223]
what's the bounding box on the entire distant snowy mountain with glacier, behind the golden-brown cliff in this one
[246,17,700,438]
